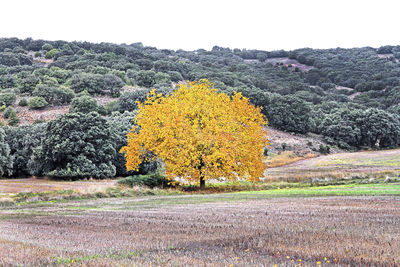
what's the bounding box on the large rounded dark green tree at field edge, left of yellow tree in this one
[42,112,116,179]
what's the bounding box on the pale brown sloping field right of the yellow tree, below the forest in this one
[265,149,400,181]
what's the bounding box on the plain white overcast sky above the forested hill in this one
[0,0,400,50]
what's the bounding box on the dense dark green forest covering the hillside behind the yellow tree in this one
[0,38,400,178]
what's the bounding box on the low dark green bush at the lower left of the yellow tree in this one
[118,173,170,188]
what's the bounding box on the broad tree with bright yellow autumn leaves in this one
[121,80,268,188]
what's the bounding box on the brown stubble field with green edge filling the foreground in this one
[0,189,400,266]
